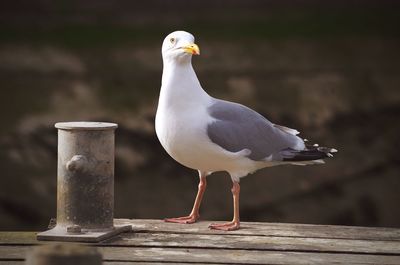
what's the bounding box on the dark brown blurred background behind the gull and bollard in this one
[0,0,400,230]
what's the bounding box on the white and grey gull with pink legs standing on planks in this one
[155,31,337,231]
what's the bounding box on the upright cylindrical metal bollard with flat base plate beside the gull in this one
[37,122,131,242]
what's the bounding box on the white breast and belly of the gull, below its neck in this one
[156,100,266,177]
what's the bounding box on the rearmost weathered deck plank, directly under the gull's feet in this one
[115,219,400,241]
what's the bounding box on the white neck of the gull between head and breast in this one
[159,62,210,108]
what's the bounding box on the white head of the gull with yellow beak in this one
[161,31,200,62]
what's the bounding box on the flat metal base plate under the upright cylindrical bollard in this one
[36,225,132,243]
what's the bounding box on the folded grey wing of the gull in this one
[207,100,302,160]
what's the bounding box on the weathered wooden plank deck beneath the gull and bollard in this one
[0,219,400,265]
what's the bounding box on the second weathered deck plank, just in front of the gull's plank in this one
[102,233,400,256]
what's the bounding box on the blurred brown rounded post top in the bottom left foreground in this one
[25,243,102,265]
